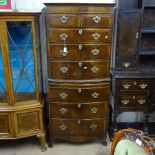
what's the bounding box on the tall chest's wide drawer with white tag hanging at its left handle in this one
[48,44,111,61]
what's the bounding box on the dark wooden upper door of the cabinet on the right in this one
[117,12,140,59]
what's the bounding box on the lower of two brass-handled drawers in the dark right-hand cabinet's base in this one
[119,95,148,107]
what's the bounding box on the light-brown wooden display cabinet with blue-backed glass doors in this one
[0,13,46,151]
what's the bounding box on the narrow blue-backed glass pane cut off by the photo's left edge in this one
[0,42,7,104]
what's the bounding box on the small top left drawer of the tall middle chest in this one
[46,14,81,28]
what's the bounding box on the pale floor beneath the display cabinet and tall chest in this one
[0,138,111,155]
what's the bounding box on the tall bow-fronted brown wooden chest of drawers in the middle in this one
[46,4,114,145]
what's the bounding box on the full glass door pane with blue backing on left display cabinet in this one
[7,21,37,102]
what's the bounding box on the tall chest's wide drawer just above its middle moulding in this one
[48,61,110,80]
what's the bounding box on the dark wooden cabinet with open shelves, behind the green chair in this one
[111,0,155,139]
